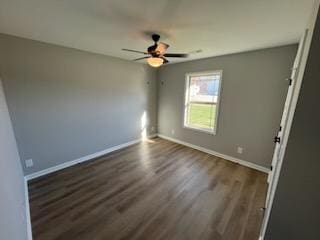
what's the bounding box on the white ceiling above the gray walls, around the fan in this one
[0,0,313,62]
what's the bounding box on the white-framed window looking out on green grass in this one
[184,71,222,134]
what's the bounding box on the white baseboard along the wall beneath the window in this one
[158,134,270,173]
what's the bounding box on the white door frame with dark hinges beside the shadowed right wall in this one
[259,0,320,240]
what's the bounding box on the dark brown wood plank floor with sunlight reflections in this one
[29,138,267,240]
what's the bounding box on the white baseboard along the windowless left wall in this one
[25,134,157,181]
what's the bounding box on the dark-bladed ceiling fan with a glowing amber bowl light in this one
[122,34,189,67]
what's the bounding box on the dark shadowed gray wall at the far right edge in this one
[265,8,320,240]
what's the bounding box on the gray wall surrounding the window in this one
[158,45,297,167]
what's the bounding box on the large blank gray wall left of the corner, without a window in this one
[0,34,157,174]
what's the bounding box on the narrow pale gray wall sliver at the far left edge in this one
[0,79,27,240]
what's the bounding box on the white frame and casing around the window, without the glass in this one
[183,70,223,135]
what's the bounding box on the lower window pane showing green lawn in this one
[187,103,216,129]
